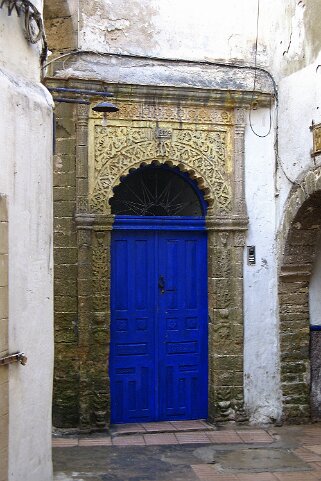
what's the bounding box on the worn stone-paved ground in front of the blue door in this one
[53,421,321,481]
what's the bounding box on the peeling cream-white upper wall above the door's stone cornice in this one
[75,0,321,79]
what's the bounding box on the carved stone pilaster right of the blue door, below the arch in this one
[207,218,246,421]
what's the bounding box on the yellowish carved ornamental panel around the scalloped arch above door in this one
[90,104,233,214]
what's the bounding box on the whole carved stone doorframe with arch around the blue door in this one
[51,81,270,431]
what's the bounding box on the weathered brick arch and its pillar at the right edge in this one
[279,168,321,422]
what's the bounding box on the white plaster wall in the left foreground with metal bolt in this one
[0,8,53,481]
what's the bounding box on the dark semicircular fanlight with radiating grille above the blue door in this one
[110,167,204,216]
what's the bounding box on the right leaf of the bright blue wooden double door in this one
[158,232,208,420]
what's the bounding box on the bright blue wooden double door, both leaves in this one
[110,223,208,423]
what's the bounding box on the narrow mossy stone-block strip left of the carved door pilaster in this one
[53,102,80,427]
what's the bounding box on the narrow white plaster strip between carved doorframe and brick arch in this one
[244,109,281,423]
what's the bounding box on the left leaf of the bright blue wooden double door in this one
[110,231,155,423]
